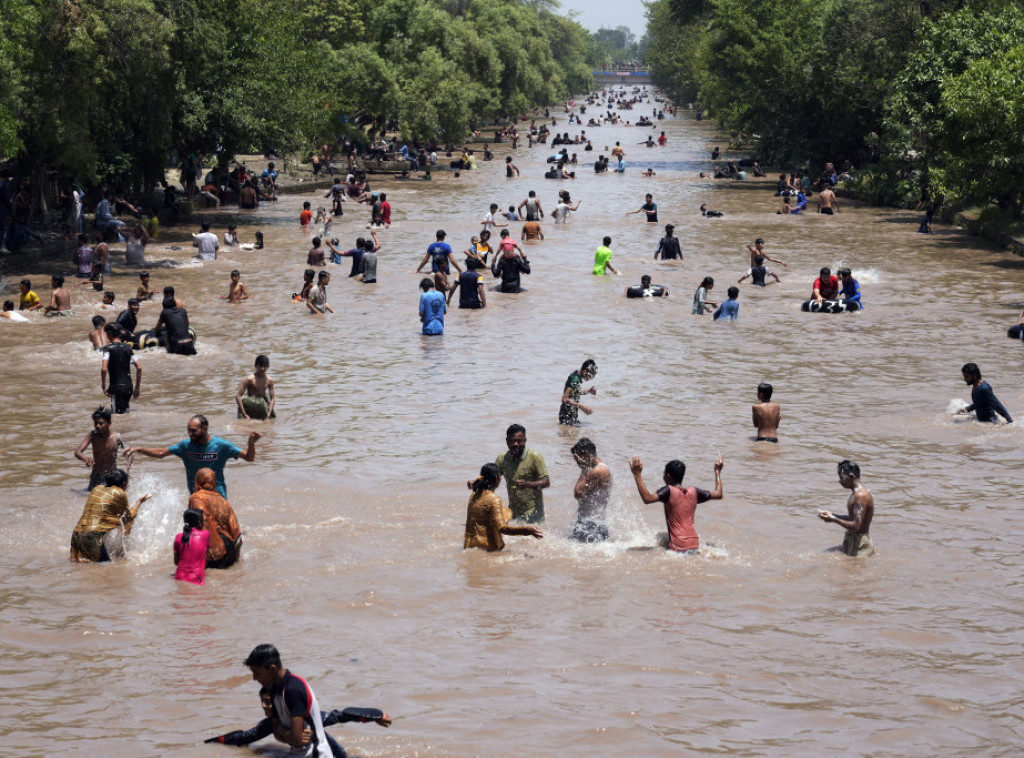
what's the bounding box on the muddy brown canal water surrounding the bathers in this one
[0,101,1024,758]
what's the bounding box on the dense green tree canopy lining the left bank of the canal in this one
[0,0,593,192]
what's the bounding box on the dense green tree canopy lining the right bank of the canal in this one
[647,0,1024,217]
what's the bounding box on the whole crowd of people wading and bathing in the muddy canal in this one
[3,81,1024,756]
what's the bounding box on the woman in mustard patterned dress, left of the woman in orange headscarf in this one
[71,468,153,563]
